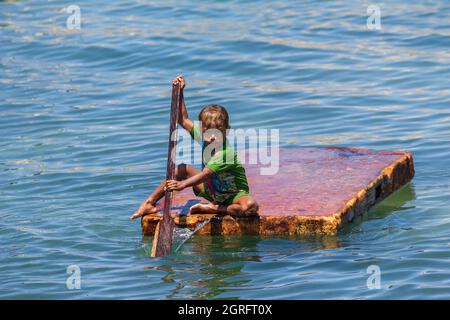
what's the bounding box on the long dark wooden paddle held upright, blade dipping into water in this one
[151,83,181,257]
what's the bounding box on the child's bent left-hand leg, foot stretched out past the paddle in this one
[131,163,203,220]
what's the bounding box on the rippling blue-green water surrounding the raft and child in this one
[0,0,450,299]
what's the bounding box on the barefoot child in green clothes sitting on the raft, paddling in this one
[131,76,258,220]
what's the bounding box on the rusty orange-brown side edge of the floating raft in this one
[141,150,415,236]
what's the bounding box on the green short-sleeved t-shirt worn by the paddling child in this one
[190,124,249,203]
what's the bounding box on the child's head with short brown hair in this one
[198,104,230,144]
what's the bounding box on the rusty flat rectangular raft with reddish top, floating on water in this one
[141,147,414,235]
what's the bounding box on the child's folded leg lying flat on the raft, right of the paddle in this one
[190,194,259,216]
